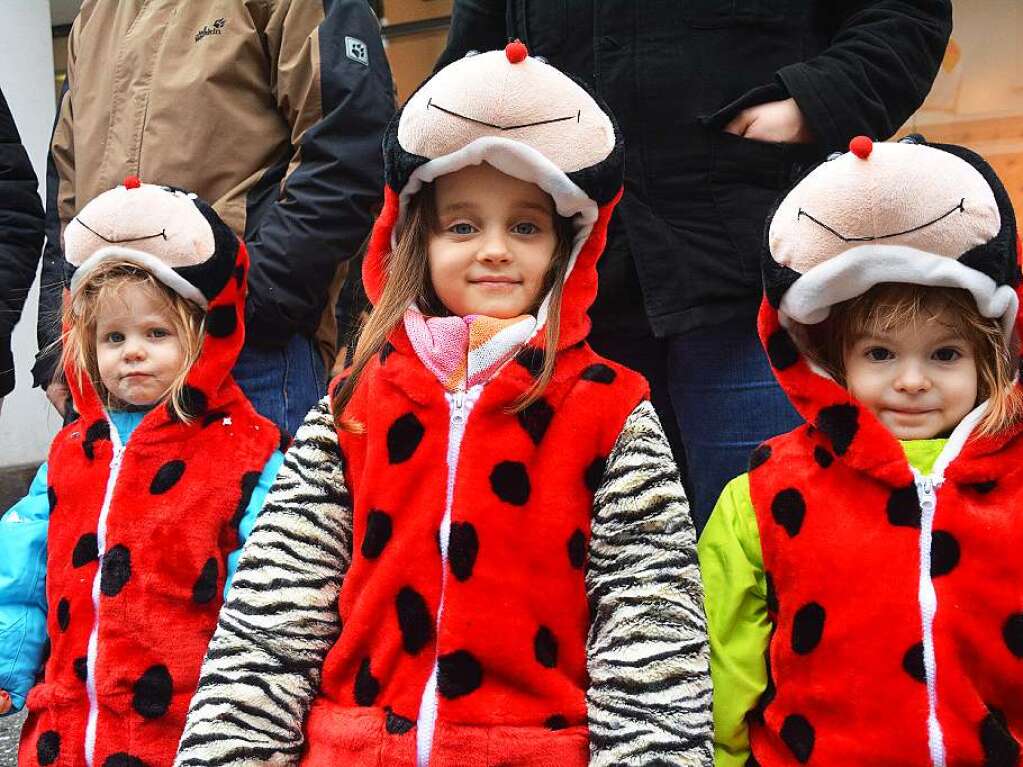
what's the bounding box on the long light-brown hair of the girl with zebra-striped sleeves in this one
[330,184,573,433]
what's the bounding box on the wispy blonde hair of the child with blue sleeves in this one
[58,261,206,423]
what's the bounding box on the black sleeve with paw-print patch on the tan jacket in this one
[246,0,395,346]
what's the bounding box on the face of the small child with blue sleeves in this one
[96,284,184,406]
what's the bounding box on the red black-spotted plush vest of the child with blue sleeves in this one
[18,189,282,767]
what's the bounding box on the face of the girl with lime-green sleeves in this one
[845,317,977,440]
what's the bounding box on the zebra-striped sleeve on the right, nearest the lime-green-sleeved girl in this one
[586,402,714,767]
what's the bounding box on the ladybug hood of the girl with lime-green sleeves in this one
[759,136,1023,480]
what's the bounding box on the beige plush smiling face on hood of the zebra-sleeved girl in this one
[398,46,615,173]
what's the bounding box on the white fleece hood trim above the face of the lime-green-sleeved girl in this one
[779,243,1019,341]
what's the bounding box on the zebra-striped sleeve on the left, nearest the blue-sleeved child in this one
[175,398,352,767]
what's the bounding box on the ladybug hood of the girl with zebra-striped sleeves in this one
[362,41,624,348]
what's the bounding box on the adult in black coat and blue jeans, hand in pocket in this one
[438,0,951,529]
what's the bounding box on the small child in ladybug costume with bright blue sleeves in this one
[0,178,283,767]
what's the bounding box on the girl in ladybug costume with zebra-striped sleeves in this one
[178,43,711,767]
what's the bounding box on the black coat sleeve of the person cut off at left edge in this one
[0,93,43,397]
